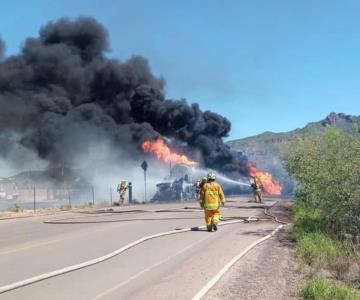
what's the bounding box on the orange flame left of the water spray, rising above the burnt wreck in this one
[141,138,197,166]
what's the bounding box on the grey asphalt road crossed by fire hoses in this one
[0,198,278,300]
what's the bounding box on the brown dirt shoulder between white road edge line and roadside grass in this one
[204,202,300,300]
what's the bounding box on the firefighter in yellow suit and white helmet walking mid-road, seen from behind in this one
[200,172,225,231]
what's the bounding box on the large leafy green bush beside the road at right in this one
[285,128,360,243]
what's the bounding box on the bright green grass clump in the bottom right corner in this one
[300,277,360,300]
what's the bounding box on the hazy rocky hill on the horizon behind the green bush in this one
[227,112,360,194]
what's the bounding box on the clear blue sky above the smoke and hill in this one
[0,0,360,139]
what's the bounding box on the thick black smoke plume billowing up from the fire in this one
[0,17,243,174]
